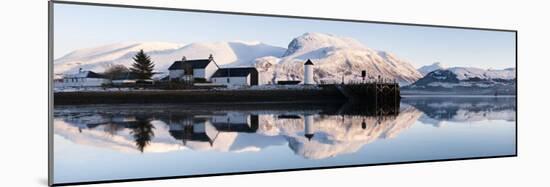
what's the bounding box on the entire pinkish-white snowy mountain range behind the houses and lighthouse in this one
[54,33,422,85]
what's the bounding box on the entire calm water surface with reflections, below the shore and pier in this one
[54,97,516,183]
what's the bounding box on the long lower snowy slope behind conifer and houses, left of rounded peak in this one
[54,42,285,76]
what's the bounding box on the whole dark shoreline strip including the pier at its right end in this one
[53,84,400,105]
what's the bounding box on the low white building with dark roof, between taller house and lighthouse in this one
[211,67,259,87]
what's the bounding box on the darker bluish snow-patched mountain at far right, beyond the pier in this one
[404,67,516,94]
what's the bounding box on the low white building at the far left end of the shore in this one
[55,70,110,88]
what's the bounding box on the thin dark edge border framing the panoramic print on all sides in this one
[47,0,518,186]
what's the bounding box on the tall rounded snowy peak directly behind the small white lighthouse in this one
[255,33,421,84]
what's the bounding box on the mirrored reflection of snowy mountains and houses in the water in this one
[54,98,516,159]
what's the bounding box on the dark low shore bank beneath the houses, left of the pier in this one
[54,89,347,105]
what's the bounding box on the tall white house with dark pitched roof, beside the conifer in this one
[168,55,220,81]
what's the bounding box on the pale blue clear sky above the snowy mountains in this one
[54,4,516,69]
